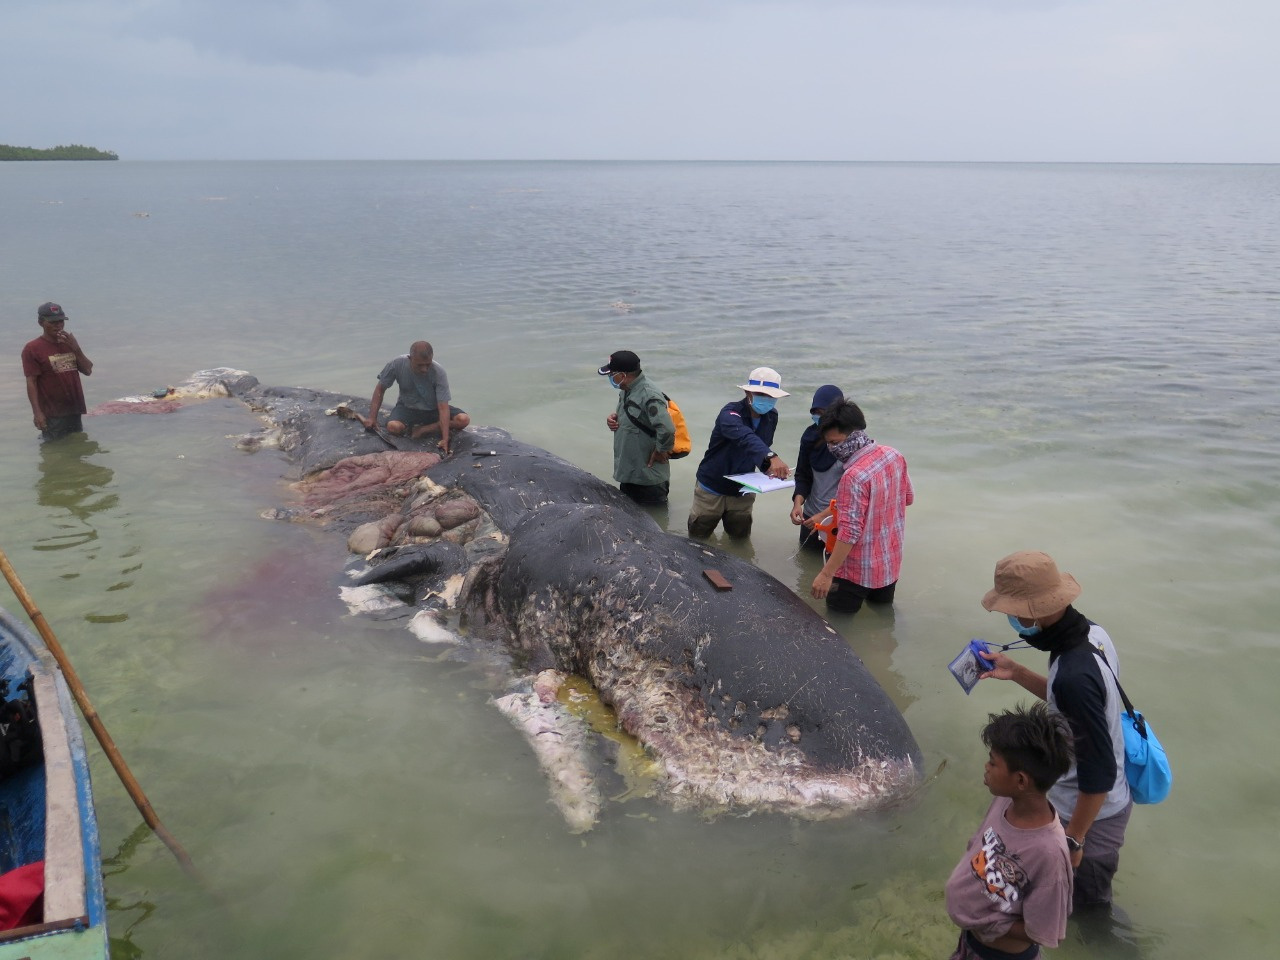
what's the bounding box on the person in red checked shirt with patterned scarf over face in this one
[805,401,915,613]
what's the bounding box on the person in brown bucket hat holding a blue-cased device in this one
[982,550,1133,913]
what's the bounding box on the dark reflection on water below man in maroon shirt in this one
[32,433,119,555]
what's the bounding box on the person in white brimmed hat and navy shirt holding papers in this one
[689,366,791,538]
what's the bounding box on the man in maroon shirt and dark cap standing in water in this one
[22,303,93,440]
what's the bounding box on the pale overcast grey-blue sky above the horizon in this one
[0,0,1280,163]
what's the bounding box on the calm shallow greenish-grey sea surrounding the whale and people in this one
[0,161,1280,960]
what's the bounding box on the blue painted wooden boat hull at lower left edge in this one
[0,609,108,960]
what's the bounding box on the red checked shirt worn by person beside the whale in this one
[836,443,915,590]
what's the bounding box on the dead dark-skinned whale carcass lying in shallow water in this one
[204,378,920,829]
